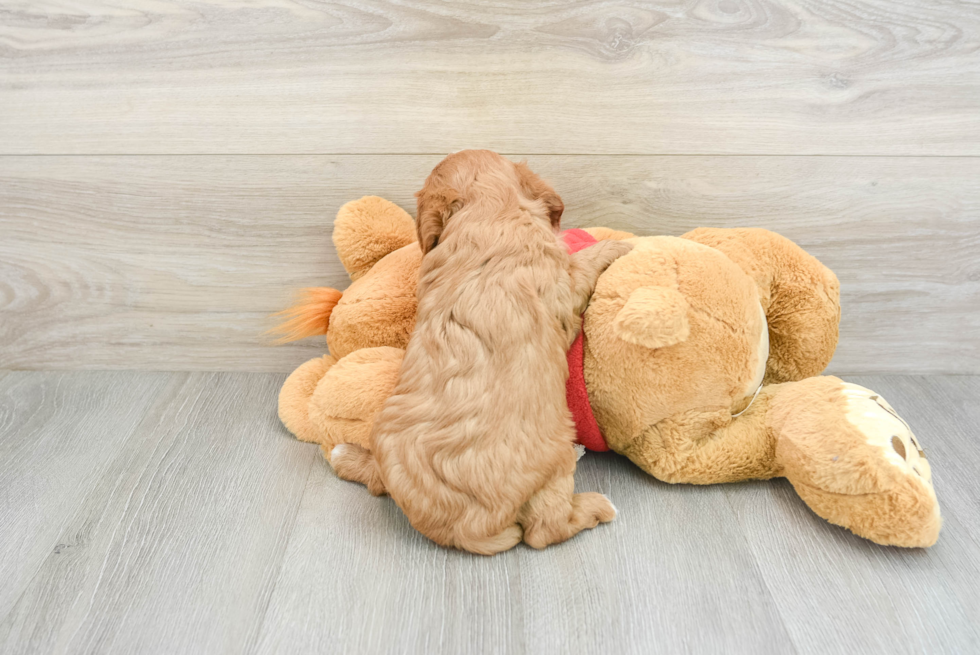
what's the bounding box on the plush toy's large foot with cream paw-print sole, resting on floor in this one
[769,377,942,547]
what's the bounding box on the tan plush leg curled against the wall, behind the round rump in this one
[683,228,840,383]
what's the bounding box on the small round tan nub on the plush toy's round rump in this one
[612,287,691,349]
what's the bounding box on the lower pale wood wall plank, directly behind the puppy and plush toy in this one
[0,155,980,373]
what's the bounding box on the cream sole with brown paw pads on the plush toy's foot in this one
[843,382,935,496]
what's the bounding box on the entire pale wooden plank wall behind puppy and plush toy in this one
[0,0,980,373]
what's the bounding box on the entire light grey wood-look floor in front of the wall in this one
[0,371,980,655]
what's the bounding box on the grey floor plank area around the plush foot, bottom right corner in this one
[725,376,980,654]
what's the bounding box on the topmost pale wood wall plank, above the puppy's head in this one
[0,0,980,155]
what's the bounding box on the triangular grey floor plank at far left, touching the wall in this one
[0,372,170,624]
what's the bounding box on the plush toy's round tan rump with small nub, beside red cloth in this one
[584,237,769,451]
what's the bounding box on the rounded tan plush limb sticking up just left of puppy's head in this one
[333,196,416,281]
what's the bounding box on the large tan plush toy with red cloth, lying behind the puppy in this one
[279,197,941,547]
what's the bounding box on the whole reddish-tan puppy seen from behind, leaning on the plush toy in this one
[331,150,631,554]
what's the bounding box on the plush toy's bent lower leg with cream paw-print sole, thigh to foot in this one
[618,376,942,547]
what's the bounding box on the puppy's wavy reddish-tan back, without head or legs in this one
[374,204,574,552]
